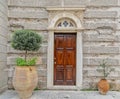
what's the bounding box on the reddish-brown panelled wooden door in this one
[54,33,76,85]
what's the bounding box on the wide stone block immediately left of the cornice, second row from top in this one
[8,9,48,19]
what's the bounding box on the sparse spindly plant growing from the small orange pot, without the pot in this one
[97,60,114,79]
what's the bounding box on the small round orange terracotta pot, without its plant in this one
[98,79,110,95]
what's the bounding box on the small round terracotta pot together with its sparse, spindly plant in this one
[97,60,114,95]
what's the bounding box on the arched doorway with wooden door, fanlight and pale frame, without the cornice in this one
[47,12,83,89]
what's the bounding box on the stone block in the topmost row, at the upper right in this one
[88,0,118,7]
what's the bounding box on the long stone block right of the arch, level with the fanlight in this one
[84,21,117,30]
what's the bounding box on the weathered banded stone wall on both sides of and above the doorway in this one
[7,0,120,90]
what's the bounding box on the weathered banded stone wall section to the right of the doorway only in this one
[83,0,120,90]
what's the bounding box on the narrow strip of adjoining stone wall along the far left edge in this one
[0,0,8,92]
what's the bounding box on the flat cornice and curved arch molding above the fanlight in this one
[46,7,85,29]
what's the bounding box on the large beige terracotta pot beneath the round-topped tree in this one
[13,66,38,99]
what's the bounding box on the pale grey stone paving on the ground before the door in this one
[0,90,120,99]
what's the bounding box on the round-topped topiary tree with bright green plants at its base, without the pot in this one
[11,30,42,66]
